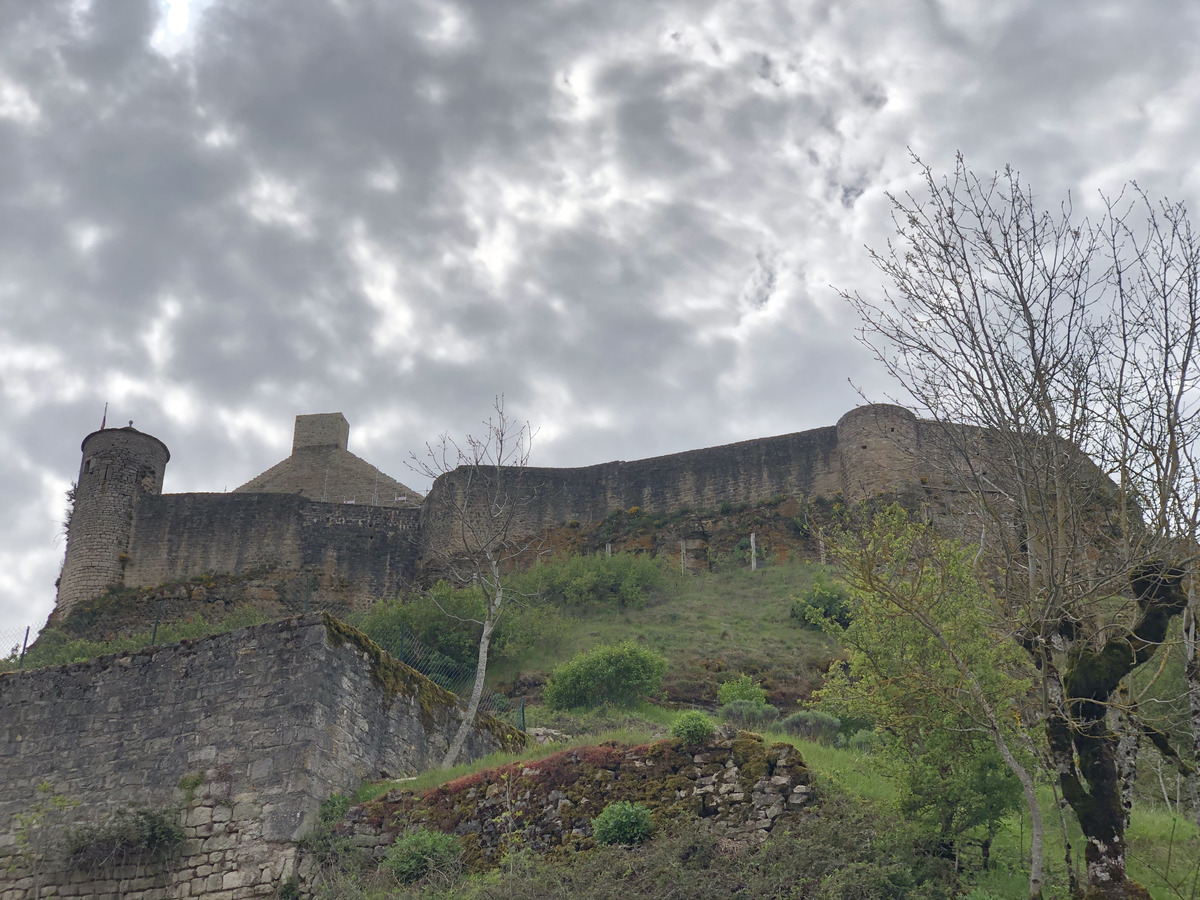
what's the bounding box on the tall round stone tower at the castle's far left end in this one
[54,427,170,617]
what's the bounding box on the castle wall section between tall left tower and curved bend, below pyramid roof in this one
[124,493,419,596]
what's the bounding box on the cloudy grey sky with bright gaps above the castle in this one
[0,0,1200,633]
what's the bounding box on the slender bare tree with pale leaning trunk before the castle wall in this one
[410,396,533,768]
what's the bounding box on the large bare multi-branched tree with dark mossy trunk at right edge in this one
[842,157,1200,898]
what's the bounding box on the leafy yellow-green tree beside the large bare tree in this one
[818,505,1043,896]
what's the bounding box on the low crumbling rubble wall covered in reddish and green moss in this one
[298,732,815,889]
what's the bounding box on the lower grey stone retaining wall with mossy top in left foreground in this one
[0,616,514,900]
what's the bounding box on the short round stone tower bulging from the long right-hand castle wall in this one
[838,403,922,503]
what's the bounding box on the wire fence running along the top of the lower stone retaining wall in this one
[0,577,524,731]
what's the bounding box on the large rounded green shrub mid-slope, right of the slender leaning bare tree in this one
[542,641,667,709]
